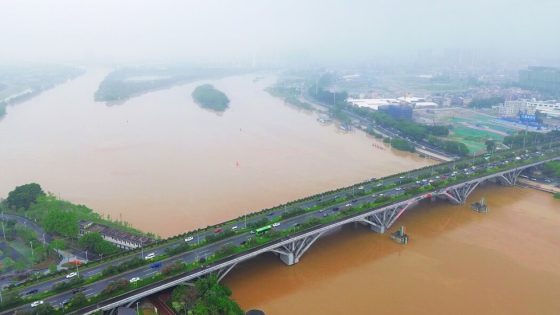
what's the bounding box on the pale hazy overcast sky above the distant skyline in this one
[0,0,560,63]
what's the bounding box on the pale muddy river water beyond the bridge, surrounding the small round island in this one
[0,70,431,236]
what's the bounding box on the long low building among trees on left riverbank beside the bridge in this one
[80,221,153,249]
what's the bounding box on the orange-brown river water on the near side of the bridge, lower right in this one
[226,186,560,315]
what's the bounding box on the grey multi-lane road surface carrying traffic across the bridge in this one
[2,146,556,314]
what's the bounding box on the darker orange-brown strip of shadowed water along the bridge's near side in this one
[224,183,507,306]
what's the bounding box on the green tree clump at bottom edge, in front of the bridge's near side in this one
[170,274,243,315]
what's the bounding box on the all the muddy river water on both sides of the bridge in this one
[0,70,560,314]
